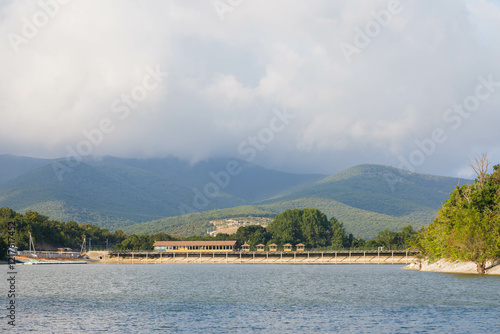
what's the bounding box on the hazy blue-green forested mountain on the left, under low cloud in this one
[0,157,324,229]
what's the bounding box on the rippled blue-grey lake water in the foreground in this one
[7,264,500,333]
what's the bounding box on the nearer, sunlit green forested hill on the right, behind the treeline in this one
[125,165,471,238]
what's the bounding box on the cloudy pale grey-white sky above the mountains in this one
[0,0,500,177]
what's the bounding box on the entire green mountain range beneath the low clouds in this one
[0,155,472,238]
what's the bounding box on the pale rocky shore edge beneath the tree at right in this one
[403,259,500,275]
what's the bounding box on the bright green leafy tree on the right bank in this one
[414,165,500,273]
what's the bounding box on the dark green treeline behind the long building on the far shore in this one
[0,208,416,254]
